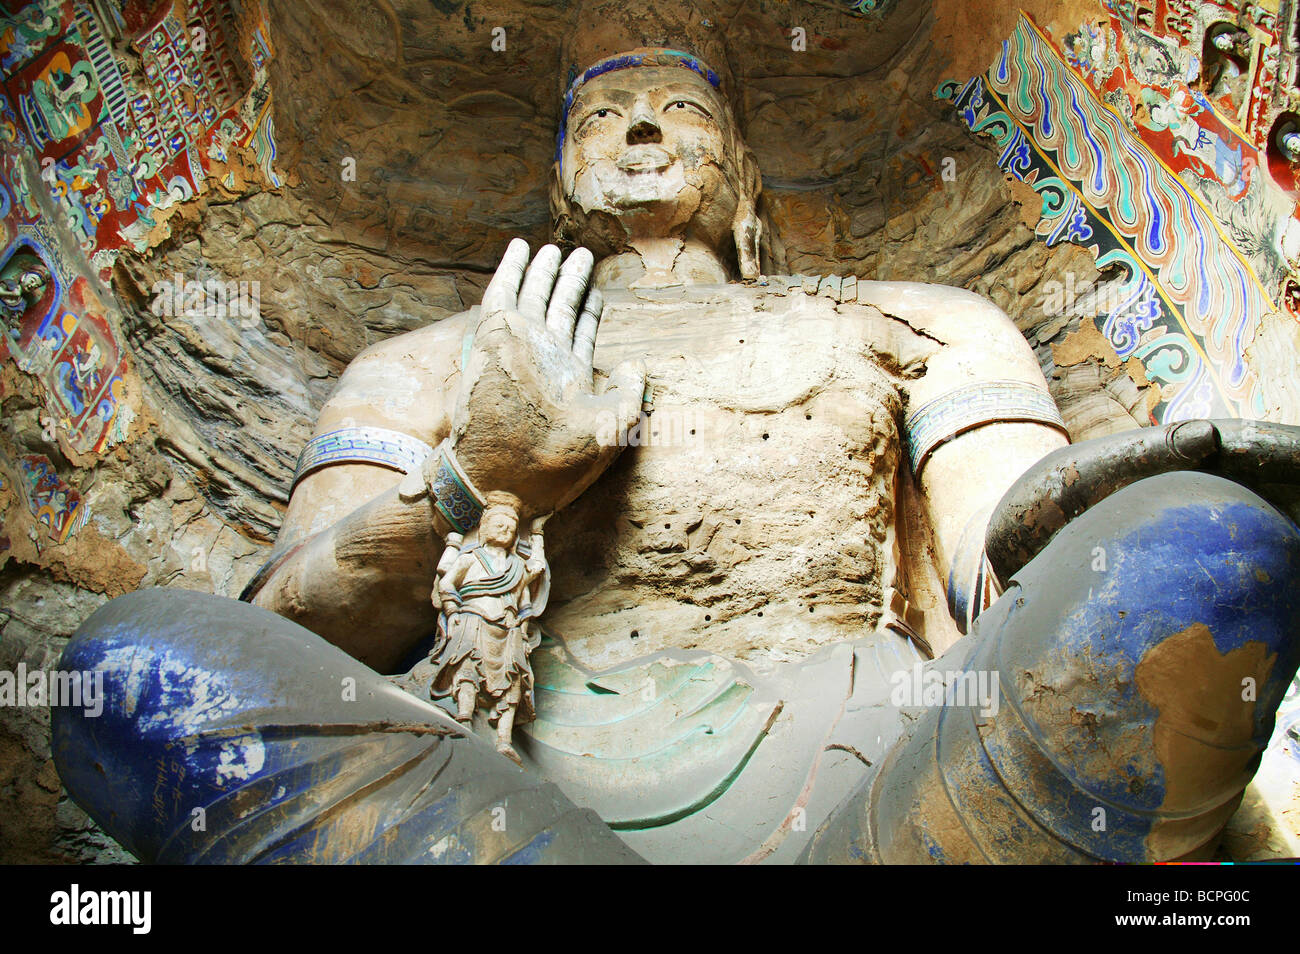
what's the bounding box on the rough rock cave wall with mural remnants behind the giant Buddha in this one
[0,0,1300,862]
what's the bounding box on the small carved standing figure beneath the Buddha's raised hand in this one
[430,491,547,762]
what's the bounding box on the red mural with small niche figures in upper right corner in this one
[1061,0,1300,317]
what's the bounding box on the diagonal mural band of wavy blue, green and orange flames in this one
[936,13,1290,422]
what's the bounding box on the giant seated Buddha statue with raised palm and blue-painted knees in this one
[53,42,1300,863]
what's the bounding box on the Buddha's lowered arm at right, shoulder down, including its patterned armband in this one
[859,282,1069,613]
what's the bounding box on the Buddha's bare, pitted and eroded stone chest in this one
[547,286,901,663]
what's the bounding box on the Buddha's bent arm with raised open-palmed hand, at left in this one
[245,239,645,669]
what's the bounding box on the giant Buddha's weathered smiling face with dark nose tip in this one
[559,66,741,251]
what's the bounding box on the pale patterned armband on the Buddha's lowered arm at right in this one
[904,381,1069,477]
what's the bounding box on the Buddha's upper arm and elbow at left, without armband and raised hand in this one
[252,332,459,671]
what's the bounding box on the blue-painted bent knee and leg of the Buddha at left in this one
[52,590,636,863]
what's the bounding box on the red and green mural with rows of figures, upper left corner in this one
[0,0,270,281]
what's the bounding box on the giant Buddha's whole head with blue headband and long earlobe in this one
[551,49,762,278]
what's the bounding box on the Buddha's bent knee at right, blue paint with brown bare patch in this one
[806,472,1300,863]
